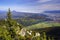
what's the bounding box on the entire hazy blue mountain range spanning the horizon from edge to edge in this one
[0,10,60,20]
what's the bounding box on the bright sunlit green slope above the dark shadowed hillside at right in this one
[27,22,60,29]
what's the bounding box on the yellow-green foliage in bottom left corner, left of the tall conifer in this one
[0,26,12,40]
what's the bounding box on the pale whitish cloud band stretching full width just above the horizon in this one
[0,4,60,13]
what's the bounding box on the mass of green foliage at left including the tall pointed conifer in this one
[0,9,21,40]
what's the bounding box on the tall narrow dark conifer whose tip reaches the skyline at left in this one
[7,8,15,38]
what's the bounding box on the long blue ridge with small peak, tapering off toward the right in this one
[0,11,47,18]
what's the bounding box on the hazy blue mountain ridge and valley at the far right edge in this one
[44,10,60,21]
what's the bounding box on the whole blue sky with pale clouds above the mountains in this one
[0,0,60,13]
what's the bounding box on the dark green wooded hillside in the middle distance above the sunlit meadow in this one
[15,18,43,26]
